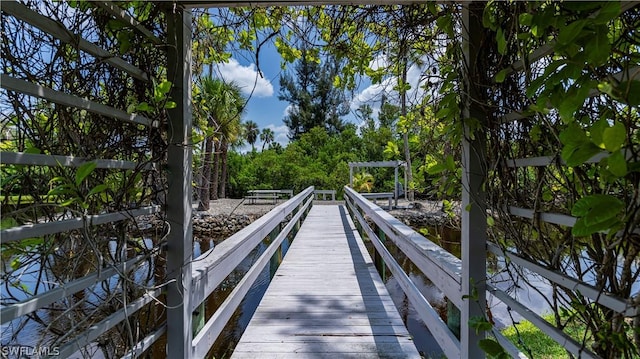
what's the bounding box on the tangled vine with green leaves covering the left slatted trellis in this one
[0,1,176,357]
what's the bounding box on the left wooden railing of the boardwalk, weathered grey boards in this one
[190,187,314,358]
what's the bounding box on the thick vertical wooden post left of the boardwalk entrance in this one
[167,5,193,358]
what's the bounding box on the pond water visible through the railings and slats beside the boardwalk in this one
[5,219,640,359]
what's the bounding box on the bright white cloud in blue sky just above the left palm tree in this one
[217,59,273,97]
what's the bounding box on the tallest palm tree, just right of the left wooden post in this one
[194,77,245,211]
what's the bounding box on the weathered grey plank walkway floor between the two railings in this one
[231,205,420,359]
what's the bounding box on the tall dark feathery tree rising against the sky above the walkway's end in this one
[278,49,349,140]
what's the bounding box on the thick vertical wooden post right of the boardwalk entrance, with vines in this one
[460,2,487,358]
